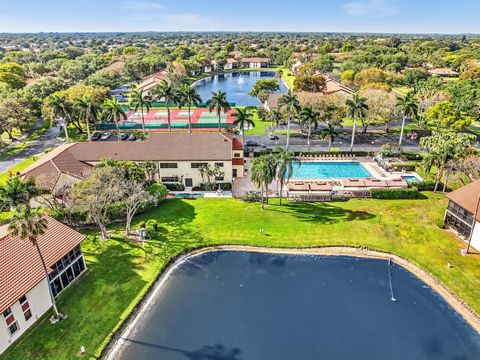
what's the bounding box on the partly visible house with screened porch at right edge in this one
[445,180,480,251]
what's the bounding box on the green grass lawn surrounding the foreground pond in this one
[3,194,480,360]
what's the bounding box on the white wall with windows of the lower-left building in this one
[0,278,52,354]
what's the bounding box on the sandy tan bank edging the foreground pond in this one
[100,245,480,360]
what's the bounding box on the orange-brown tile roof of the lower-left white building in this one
[0,217,85,313]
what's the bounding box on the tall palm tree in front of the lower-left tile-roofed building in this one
[8,206,60,317]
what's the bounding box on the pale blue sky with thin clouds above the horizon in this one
[0,0,480,33]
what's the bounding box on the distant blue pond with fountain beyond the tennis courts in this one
[194,71,288,106]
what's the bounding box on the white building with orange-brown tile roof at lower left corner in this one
[0,218,86,354]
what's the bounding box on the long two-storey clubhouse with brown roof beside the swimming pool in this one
[21,132,244,193]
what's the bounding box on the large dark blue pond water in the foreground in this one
[115,251,480,360]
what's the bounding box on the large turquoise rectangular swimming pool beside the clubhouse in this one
[286,161,372,179]
